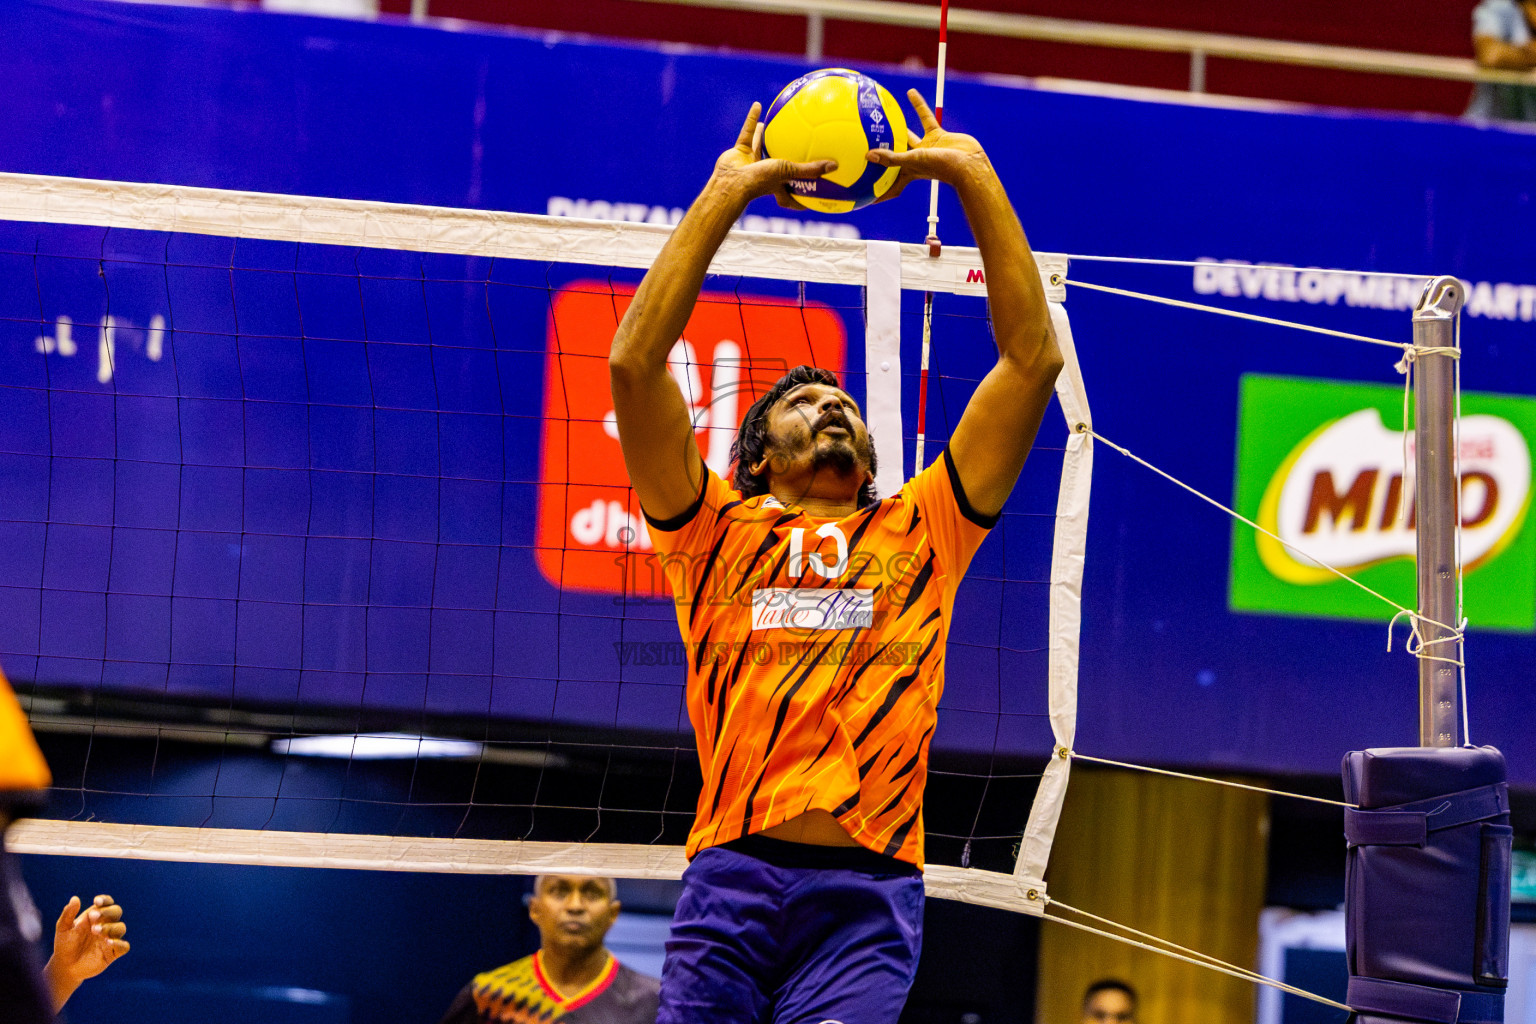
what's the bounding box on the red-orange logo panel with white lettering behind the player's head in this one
[536,281,846,597]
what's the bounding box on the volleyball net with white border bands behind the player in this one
[0,175,1092,910]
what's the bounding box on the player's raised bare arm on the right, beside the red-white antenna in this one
[871,89,1061,516]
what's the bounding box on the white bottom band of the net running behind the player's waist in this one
[5,818,1044,917]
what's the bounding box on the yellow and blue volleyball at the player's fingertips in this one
[763,68,906,213]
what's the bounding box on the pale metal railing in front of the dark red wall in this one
[412,0,1536,92]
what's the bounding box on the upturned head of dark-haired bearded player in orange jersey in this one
[731,365,877,508]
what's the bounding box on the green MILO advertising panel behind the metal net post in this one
[1230,375,1536,631]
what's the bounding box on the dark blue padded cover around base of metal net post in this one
[1344,746,1513,1024]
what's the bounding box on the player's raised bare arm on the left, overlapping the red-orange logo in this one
[608,103,837,519]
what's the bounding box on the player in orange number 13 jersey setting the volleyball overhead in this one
[610,91,1061,1024]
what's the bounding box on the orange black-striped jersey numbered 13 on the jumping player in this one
[648,454,995,867]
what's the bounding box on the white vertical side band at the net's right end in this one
[1014,297,1094,894]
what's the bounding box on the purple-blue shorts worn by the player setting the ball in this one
[656,835,923,1024]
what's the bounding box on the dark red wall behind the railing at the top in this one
[381,0,1475,114]
